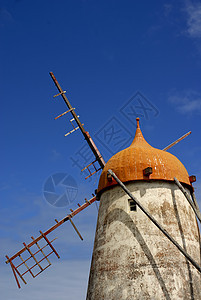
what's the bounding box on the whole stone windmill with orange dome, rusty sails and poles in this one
[6,72,201,300]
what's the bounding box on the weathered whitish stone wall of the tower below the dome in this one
[87,181,201,300]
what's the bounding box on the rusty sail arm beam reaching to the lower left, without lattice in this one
[6,196,96,264]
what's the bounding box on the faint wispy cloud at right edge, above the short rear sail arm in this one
[168,90,201,115]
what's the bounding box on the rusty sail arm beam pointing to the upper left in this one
[50,72,105,169]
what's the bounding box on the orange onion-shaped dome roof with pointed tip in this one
[98,118,191,193]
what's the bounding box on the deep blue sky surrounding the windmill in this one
[0,0,201,300]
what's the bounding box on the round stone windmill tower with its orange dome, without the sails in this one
[87,118,201,300]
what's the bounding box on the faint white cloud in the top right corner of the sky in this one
[185,1,201,38]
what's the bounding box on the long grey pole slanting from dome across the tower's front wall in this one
[108,170,201,273]
